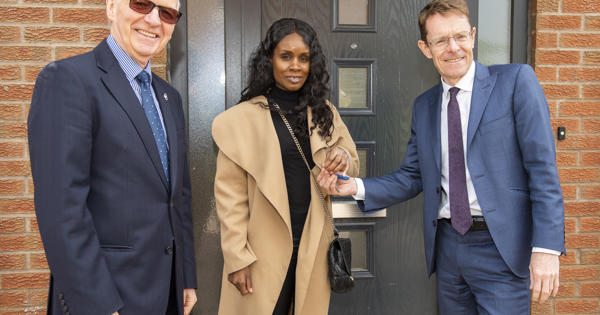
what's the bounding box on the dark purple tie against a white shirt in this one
[448,87,473,235]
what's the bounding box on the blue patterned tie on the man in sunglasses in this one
[135,71,169,182]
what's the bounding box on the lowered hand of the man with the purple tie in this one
[529,252,560,304]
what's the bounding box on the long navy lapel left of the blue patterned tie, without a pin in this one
[94,40,167,191]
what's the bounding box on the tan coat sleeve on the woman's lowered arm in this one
[215,150,256,274]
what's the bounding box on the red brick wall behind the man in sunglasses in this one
[0,0,167,315]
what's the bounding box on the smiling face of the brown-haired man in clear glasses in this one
[418,12,475,85]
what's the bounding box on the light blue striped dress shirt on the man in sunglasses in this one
[106,35,169,141]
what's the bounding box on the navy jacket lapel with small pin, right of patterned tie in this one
[152,78,179,191]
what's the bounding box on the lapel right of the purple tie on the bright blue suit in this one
[467,63,497,151]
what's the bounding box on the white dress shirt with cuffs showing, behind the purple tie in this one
[352,61,560,255]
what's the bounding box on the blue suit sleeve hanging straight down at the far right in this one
[513,65,565,253]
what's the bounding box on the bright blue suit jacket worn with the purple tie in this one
[359,63,565,277]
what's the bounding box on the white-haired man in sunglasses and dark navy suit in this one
[28,0,196,315]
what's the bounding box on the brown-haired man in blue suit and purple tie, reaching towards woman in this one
[319,0,565,314]
